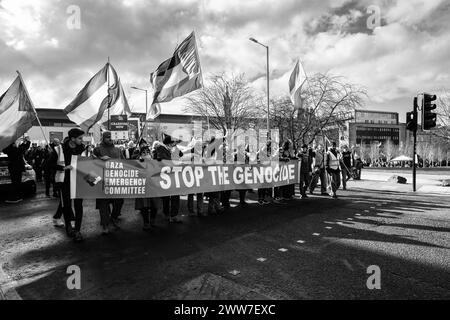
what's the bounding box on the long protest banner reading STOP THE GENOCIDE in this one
[71,156,300,199]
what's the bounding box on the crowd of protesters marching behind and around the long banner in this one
[4,128,363,242]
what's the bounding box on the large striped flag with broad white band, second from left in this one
[64,63,131,132]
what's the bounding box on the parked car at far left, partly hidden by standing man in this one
[0,153,36,195]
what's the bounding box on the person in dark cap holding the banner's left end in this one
[60,128,85,242]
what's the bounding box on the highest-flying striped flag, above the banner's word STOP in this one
[148,32,203,119]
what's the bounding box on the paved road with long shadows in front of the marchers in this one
[0,170,450,300]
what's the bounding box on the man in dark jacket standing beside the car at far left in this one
[3,138,30,204]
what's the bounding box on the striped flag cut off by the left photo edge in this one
[0,76,36,151]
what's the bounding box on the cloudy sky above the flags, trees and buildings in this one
[0,0,450,120]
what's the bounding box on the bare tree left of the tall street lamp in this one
[186,74,259,134]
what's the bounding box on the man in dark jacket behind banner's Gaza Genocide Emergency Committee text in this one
[94,132,124,235]
